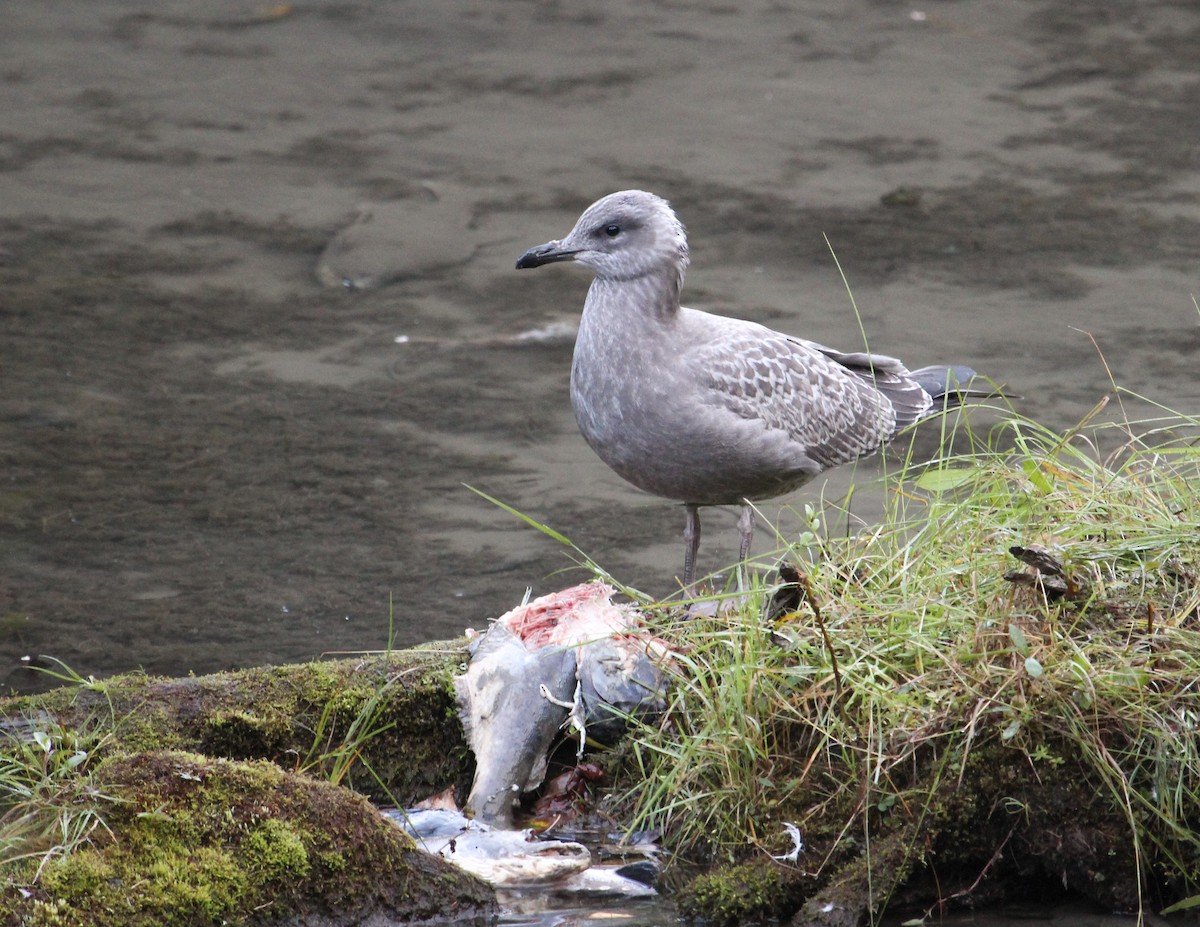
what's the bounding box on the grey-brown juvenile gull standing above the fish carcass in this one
[517,190,974,590]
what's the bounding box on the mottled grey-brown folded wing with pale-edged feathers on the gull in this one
[704,327,902,467]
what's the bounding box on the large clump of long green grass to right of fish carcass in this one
[624,398,1200,912]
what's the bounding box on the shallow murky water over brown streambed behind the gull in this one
[0,0,1200,688]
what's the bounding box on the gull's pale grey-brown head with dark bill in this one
[517,190,688,282]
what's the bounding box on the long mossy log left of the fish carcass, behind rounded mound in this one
[0,640,474,805]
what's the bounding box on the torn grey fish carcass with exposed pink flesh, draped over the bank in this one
[455,582,667,827]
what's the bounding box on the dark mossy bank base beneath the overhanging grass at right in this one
[678,742,1152,927]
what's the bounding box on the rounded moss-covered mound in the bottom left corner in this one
[0,752,494,927]
